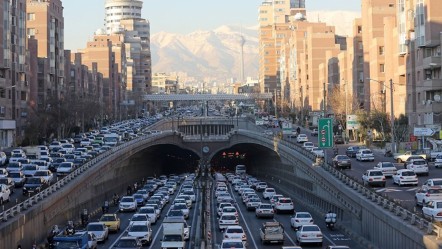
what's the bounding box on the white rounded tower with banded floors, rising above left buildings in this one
[104,0,143,35]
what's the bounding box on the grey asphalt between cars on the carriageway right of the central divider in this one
[210,173,362,249]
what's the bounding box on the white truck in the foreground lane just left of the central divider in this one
[161,217,186,249]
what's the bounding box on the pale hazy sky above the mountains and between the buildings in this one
[63,0,361,50]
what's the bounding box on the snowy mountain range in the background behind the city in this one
[151,11,359,82]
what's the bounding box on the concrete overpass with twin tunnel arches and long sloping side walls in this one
[0,117,441,248]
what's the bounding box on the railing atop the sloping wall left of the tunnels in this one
[0,129,173,225]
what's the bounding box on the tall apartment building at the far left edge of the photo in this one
[0,0,29,147]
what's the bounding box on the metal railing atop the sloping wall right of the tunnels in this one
[238,130,442,238]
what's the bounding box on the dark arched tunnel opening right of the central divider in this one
[210,143,281,173]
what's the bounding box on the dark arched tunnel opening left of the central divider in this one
[130,144,200,177]
